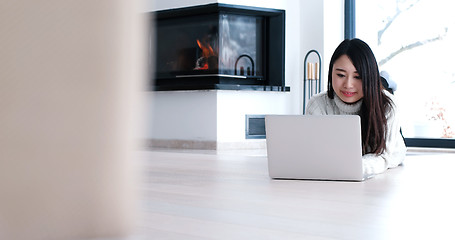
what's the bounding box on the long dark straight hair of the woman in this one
[327,38,392,154]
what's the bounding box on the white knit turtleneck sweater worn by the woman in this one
[306,91,406,176]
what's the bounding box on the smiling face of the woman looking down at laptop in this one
[332,55,363,103]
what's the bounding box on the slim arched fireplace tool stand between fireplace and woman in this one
[303,49,321,114]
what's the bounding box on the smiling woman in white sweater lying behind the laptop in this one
[307,39,406,176]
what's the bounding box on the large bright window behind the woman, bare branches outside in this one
[352,0,455,148]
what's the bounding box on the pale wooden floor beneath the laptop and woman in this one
[130,150,455,240]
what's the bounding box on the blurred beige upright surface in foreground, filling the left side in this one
[0,0,144,240]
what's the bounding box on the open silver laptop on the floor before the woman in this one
[265,115,366,181]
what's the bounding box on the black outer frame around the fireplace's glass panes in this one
[150,3,289,91]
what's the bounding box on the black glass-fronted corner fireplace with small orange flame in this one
[151,3,286,91]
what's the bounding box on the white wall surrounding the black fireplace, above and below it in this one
[145,0,342,149]
